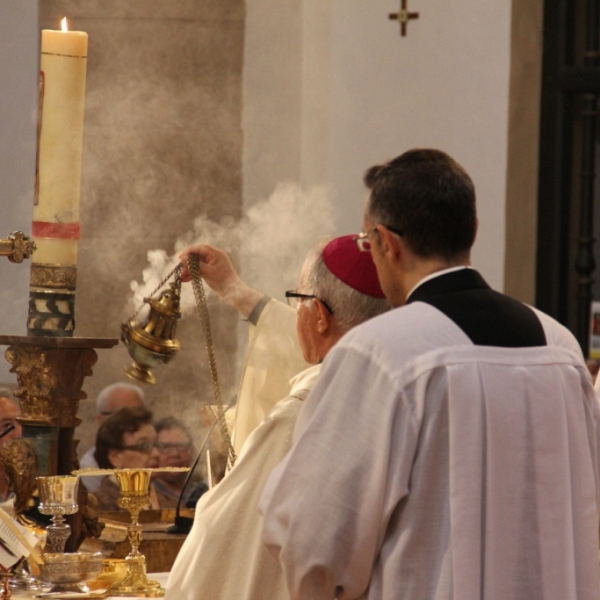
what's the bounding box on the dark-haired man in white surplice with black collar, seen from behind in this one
[261,150,600,600]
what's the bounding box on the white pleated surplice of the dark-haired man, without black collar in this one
[263,292,598,600]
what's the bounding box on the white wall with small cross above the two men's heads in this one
[243,0,510,289]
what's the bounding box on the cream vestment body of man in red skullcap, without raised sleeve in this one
[165,365,321,600]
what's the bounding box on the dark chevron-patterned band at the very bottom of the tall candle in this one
[27,289,75,337]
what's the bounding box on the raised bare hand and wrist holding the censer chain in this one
[179,244,262,317]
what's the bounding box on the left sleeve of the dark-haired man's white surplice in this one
[260,345,418,600]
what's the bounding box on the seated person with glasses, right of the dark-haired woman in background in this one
[152,417,208,508]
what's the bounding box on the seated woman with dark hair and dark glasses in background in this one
[94,408,160,512]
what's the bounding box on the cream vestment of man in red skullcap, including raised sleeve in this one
[165,300,312,600]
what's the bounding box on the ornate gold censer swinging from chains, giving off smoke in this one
[121,265,181,383]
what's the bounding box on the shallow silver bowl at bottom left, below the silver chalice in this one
[38,552,102,592]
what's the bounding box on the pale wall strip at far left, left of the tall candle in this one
[0,0,39,382]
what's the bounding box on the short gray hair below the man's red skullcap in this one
[302,237,391,333]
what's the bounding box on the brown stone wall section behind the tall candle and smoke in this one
[40,0,245,450]
